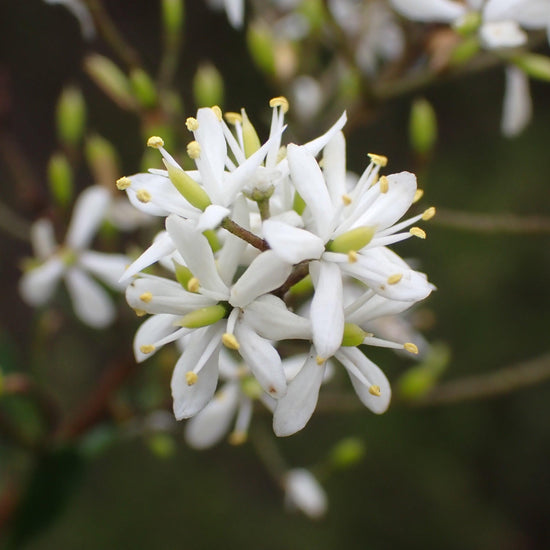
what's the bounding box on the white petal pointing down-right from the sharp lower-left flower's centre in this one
[235,322,286,399]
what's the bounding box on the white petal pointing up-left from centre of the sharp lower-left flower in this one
[166,216,228,300]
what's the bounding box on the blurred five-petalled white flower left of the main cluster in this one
[19,186,129,328]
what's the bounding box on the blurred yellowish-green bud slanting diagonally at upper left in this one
[84,54,136,110]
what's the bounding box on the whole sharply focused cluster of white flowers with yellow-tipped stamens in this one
[117,97,435,447]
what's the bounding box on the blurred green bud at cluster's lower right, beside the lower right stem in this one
[397,344,451,400]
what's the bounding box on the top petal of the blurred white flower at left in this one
[66,185,110,249]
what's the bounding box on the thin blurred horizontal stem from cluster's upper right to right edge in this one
[432,208,550,234]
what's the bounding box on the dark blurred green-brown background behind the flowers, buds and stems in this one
[0,0,550,550]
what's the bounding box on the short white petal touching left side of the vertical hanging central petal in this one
[243,294,311,340]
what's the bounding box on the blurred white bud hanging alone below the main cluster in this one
[283,468,328,519]
